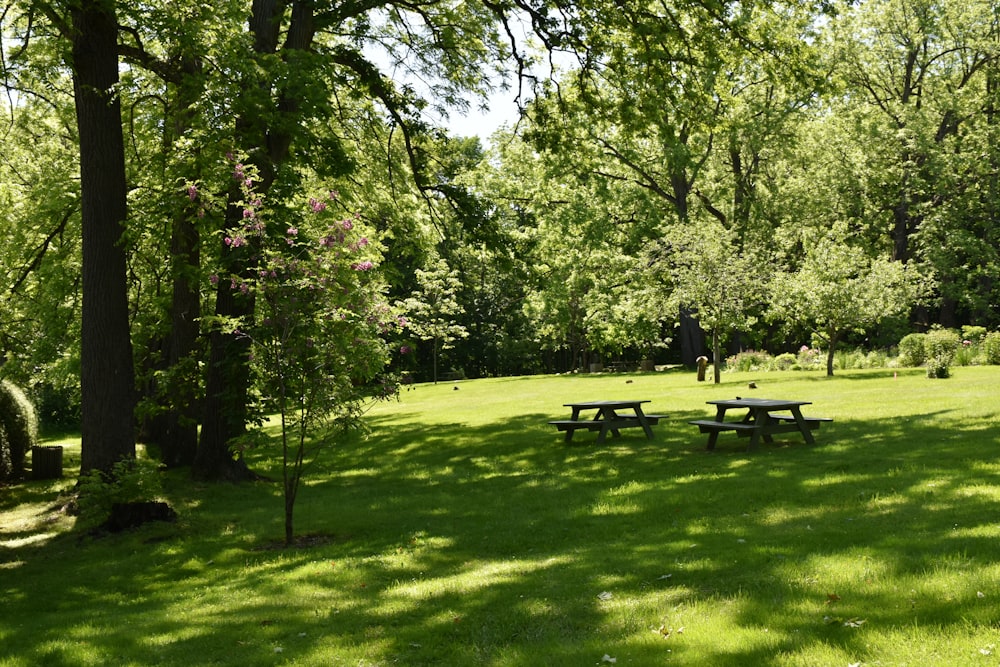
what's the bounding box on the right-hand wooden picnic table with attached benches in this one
[690,396,833,451]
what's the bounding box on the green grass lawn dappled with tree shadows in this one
[0,367,1000,667]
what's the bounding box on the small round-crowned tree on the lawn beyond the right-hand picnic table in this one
[771,229,923,376]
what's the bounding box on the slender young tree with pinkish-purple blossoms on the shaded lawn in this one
[221,179,400,545]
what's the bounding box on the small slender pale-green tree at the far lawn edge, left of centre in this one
[398,259,469,384]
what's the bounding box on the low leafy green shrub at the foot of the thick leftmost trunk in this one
[77,456,163,527]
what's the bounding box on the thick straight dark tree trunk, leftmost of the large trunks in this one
[72,0,135,473]
